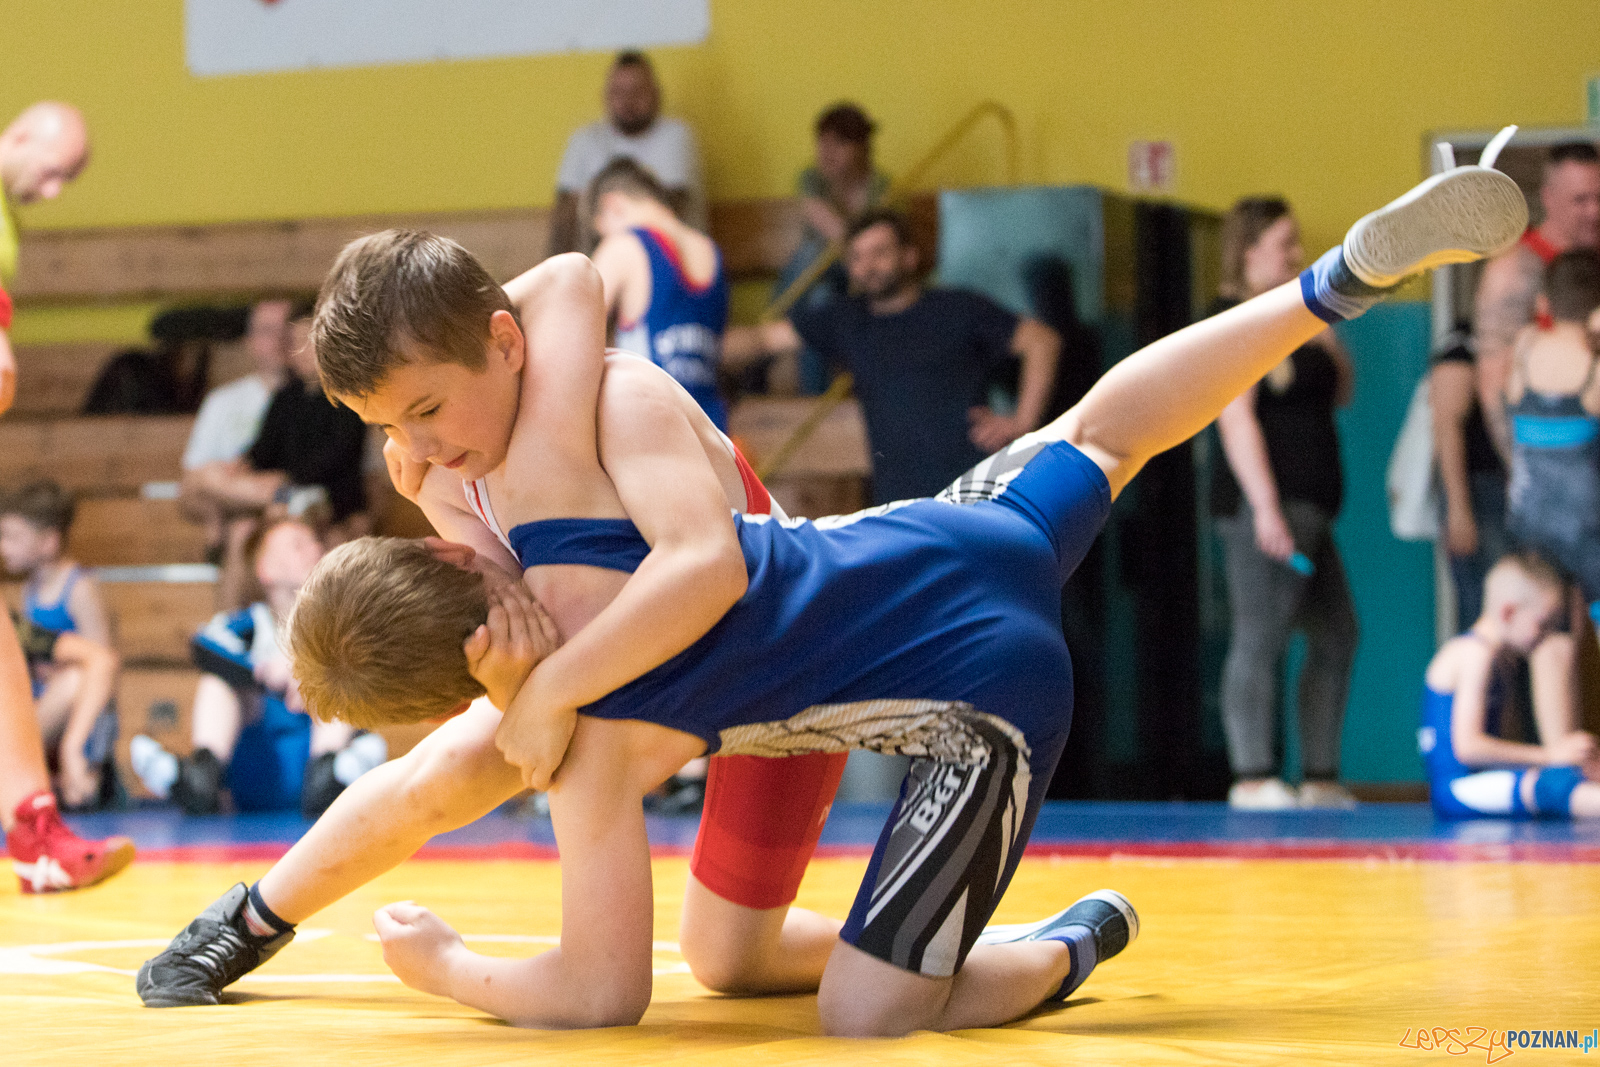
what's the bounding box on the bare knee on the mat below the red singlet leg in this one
[678,875,843,995]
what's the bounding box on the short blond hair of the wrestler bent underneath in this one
[288,537,488,729]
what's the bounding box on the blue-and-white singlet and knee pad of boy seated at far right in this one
[1416,646,1584,819]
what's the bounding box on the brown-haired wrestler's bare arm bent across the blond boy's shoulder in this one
[496,362,749,789]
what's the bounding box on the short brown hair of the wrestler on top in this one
[310,230,515,397]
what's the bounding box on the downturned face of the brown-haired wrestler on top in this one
[339,310,523,480]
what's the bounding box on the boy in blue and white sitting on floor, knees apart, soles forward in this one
[130,520,387,817]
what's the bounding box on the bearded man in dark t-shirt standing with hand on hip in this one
[723,211,1061,504]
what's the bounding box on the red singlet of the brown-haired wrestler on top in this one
[690,448,848,910]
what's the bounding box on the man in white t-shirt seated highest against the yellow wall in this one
[549,51,706,256]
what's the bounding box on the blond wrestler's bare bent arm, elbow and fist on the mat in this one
[373,720,653,1029]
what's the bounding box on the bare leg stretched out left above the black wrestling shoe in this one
[259,699,522,923]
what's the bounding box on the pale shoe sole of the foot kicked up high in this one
[1344,166,1528,290]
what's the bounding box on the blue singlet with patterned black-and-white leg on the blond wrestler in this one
[510,442,1110,976]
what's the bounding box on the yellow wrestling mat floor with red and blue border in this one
[0,803,1600,1067]
